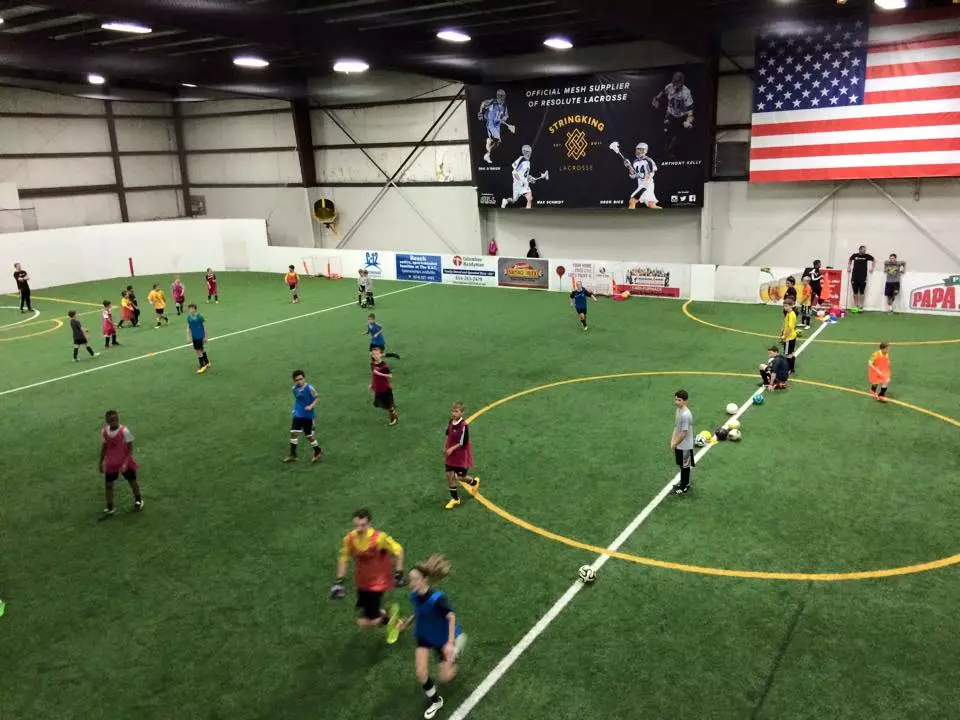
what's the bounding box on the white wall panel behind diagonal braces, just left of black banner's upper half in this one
[310,101,468,145]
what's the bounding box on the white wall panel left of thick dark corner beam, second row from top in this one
[183,112,297,152]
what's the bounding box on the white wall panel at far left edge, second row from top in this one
[0,118,110,154]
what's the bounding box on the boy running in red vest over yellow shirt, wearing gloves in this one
[330,508,406,641]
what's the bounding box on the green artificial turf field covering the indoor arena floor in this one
[0,273,960,720]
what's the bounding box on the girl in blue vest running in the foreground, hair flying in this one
[396,555,467,720]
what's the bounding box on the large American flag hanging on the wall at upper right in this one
[750,8,960,182]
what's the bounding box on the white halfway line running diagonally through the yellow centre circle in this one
[450,322,827,720]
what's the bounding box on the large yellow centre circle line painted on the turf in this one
[467,370,960,582]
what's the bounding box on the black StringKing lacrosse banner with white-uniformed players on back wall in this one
[467,65,710,211]
